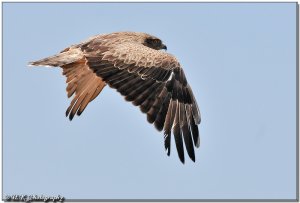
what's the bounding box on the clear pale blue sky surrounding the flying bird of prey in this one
[3,3,296,199]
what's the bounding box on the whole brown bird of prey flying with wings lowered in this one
[29,32,201,163]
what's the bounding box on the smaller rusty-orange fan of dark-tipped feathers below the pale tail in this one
[61,58,106,120]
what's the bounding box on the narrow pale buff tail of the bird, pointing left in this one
[28,49,83,67]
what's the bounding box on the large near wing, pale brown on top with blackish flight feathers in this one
[81,43,200,163]
